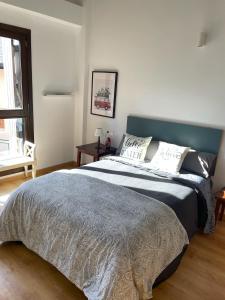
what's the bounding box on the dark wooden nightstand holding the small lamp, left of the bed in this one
[77,143,116,167]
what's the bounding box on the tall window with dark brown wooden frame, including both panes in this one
[0,23,34,164]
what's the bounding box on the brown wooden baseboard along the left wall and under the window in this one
[0,161,77,184]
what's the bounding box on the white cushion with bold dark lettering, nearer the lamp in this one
[120,134,152,161]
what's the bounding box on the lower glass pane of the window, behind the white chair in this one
[0,118,24,160]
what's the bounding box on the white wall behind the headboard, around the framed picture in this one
[80,0,225,190]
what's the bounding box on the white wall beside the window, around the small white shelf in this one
[0,4,79,168]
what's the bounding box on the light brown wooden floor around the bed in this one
[0,180,225,300]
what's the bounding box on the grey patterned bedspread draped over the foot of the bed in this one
[0,170,188,300]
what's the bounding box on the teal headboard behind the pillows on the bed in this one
[127,116,223,155]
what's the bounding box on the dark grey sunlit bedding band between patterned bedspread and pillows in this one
[78,159,207,239]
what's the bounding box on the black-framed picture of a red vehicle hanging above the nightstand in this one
[91,71,118,118]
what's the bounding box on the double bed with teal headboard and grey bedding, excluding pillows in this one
[0,116,222,300]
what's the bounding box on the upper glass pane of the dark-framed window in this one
[0,36,23,110]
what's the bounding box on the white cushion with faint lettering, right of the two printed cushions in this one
[145,142,190,173]
